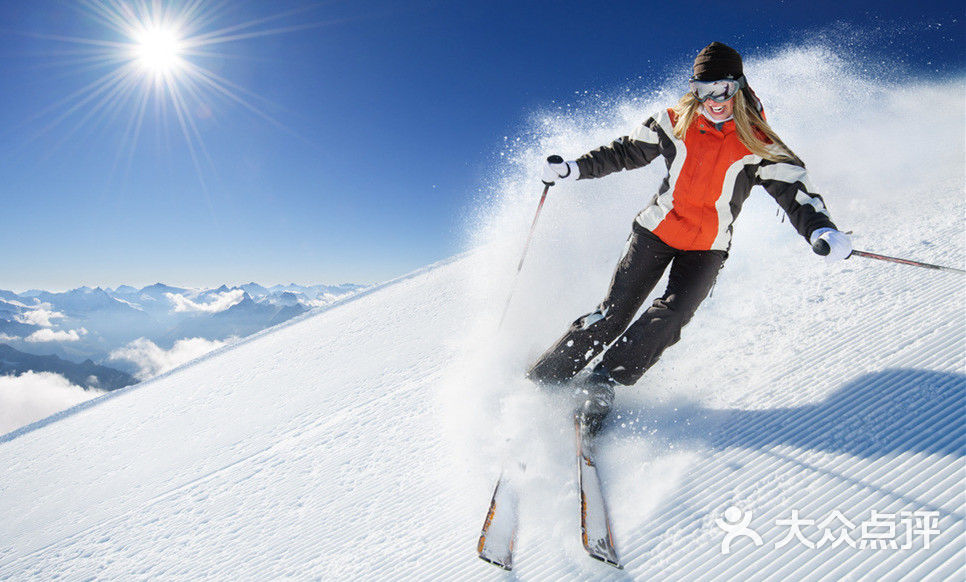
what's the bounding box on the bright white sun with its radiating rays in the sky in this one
[28,0,326,192]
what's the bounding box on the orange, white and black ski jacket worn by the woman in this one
[577,109,835,251]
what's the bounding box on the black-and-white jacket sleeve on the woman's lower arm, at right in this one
[755,160,836,240]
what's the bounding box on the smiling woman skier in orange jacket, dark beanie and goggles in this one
[527,42,852,434]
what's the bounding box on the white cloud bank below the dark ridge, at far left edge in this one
[0,372,105,434]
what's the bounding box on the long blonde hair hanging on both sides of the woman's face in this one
[671,90,805,166]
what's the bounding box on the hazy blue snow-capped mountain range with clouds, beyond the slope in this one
[0,282,364,386]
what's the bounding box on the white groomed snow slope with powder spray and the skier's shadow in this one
[0,48,966,581]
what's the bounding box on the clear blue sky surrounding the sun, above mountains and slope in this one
[0,0,966,291]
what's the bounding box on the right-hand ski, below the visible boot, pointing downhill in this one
[574,414,623,569]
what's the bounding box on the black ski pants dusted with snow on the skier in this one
[527,222,728,385]
